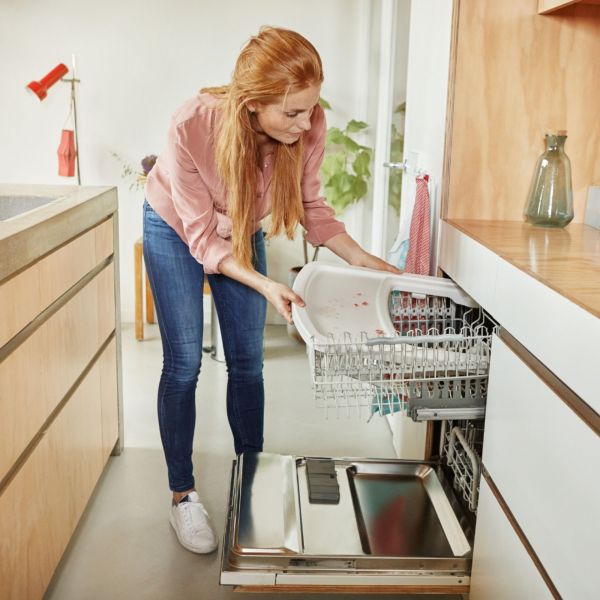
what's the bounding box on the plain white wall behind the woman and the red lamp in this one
[0,0,371,321]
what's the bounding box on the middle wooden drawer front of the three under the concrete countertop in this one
[0,263,115,480]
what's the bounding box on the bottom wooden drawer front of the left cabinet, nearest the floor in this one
[0,344,104,600]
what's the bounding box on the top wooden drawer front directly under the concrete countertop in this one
[0,218,113,347]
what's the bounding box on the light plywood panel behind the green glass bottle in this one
[441,0,600,223]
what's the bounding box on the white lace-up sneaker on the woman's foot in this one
[169,492,218,554]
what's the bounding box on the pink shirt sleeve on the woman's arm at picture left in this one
[166,123,232,274]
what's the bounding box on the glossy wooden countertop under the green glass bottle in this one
[447,219,600,317]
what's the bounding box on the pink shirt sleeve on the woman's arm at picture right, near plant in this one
[301,106,346,246]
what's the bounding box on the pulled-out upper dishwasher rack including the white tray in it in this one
[292,263,493,421]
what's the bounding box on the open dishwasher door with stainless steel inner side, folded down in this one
[221,453,472,594]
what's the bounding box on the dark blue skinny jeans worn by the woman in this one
[144,202,267,492]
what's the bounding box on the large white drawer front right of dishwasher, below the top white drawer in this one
[483,338,600,598]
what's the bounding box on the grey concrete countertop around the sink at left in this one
[0,183,117,283]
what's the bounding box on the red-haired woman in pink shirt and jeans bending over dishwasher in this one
[144,27,397,553]
